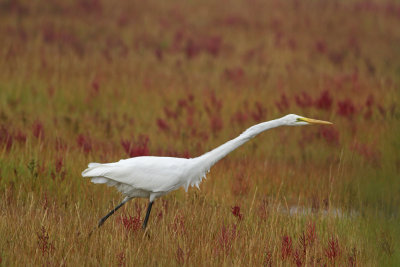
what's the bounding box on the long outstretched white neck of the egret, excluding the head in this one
[194,119,284,171]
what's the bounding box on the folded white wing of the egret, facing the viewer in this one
[82,157,188,192]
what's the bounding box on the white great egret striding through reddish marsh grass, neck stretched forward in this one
[82,114,332,229]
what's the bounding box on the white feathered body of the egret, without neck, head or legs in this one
[82,156,205,201]
